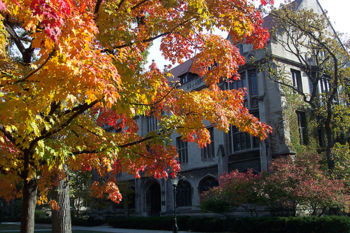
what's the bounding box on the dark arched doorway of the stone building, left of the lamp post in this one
[146,181,161,216]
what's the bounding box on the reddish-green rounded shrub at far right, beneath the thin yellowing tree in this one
[264,154,348,215]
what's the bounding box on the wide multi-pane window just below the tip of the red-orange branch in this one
[225,111,260,154]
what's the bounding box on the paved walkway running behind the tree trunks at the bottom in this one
[0,222,200,233]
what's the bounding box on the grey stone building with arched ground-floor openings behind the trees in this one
[115,0,340,216]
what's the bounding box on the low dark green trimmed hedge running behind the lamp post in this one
[109,216,350,233]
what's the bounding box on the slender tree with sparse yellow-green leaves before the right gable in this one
[265,2,350,170]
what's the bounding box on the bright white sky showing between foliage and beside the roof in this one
[145,0,350,70]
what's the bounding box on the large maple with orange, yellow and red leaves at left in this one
[0,0,270,232]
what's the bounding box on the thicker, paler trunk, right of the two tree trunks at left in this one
[52,178,72,233]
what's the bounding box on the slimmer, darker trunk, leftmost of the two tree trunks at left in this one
[21,180,38,233]
